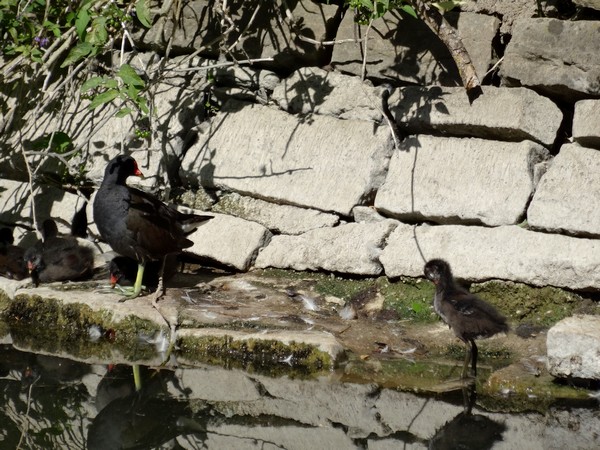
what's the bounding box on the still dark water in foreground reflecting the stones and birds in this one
[0,338,600,450]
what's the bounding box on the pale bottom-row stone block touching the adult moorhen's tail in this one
[186,211,271,270]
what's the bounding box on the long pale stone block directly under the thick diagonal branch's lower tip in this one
[389,86,563,147]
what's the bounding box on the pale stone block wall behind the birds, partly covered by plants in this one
[0,0,600,291]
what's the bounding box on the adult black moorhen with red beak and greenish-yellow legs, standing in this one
[94,155,212,301]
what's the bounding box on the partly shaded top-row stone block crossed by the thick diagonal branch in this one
[332,12,500,86]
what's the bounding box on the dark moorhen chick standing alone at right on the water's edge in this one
[424,259,508,378]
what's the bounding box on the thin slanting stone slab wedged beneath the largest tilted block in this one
[212,192,339,234]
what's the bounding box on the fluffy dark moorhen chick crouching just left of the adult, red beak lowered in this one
[24,219,94,287]
